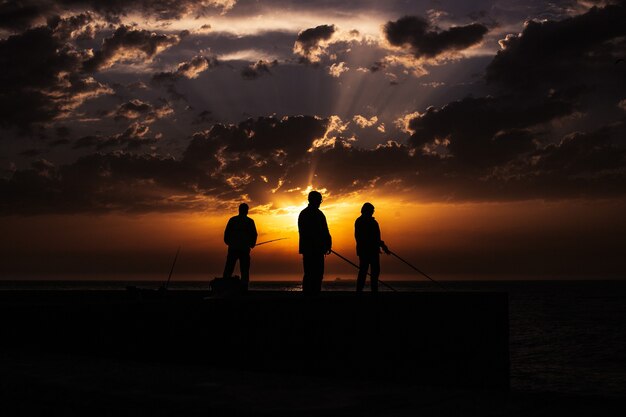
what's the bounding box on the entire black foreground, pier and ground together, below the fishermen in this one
[0,291,623,416]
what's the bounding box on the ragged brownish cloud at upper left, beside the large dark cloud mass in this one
[83,25,184,72]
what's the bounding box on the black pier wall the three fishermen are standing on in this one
[0,291,509,390]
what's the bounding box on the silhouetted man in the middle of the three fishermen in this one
[298,191,332,295]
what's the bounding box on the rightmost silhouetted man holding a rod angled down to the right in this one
[354,203,390,292]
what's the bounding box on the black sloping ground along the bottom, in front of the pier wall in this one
[0,352,626,417]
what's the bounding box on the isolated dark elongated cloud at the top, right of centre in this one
[384,16,489,58]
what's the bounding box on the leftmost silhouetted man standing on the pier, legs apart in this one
[224,203,257,291]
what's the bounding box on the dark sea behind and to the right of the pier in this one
[0,280,626,397]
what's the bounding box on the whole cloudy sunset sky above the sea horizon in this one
[0,0,626,280]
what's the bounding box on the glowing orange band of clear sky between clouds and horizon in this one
[0,195,626,280]
